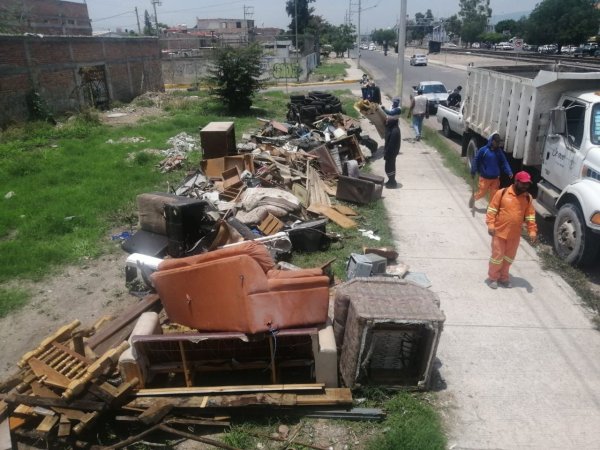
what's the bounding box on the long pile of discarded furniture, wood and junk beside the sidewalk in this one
[0,92,443,450]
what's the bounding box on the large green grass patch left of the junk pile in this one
[0,92,288,283]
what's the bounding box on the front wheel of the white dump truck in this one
[553,203,600,266]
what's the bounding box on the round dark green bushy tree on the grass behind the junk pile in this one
[209,44,263,112]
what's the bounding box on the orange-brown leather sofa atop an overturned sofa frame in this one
[152,241,329,333]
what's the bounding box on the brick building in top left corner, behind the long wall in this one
[0,0,92,36]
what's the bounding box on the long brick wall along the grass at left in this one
[0,36,164,126]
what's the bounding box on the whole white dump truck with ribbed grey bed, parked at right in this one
[463,64,600,265]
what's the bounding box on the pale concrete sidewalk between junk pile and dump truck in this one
[356,58,600,450]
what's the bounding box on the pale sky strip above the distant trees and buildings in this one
[86,0,541,33]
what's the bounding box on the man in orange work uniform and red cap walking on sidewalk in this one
[485,171,537,289]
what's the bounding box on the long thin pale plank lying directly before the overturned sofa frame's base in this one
[135,383,325,397]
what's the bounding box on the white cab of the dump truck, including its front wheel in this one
[536,92,600,264]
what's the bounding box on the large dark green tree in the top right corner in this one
[525,0,600,49]
